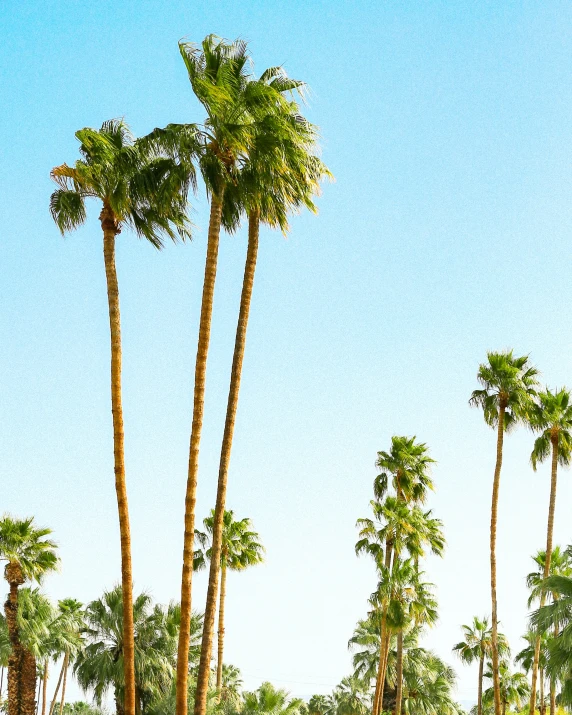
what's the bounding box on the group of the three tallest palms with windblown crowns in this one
[46,30,330,715]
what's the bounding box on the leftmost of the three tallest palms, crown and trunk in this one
[50,120,192,715]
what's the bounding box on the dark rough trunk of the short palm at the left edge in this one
[4,561,25,715]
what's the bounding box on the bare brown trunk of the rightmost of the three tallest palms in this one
[194,211,260,715]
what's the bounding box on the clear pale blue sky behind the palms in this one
[0,0,572,701]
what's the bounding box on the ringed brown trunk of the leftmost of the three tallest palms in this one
[99,203,135,715]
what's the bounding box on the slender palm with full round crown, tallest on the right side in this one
[469,350,538,715]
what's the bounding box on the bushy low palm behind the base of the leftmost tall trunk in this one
[74,586,202,715]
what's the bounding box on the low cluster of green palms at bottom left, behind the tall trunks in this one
[0,510,264,715]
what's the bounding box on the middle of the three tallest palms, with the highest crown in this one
[172,35,265,715]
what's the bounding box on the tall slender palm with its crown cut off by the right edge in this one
[529,388,572,712]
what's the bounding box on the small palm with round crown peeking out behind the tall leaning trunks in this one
[194,509,264,691]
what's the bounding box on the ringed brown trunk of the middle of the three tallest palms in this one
[175,193,223,715]
